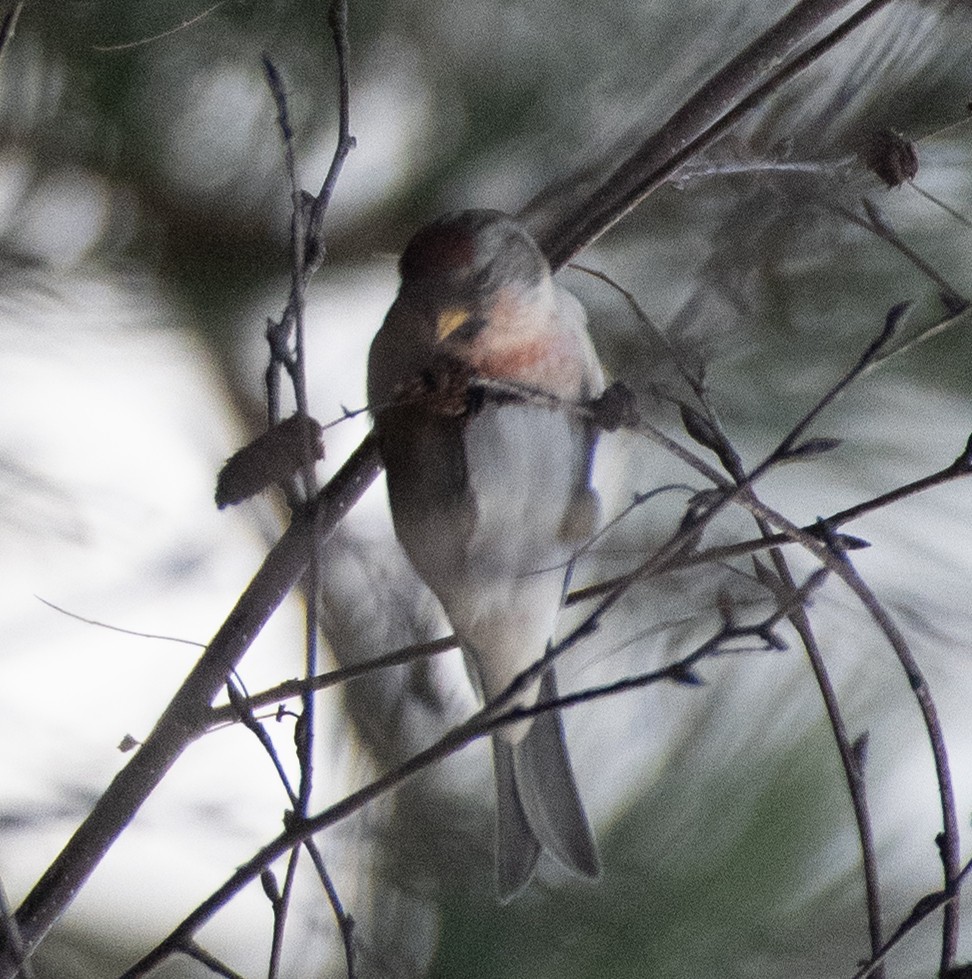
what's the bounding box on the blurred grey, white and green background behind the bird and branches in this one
[0,0,972,979]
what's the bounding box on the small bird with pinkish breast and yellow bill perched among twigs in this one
[368,210,604,901]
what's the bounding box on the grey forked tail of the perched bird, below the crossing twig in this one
[493,670,601,901]
